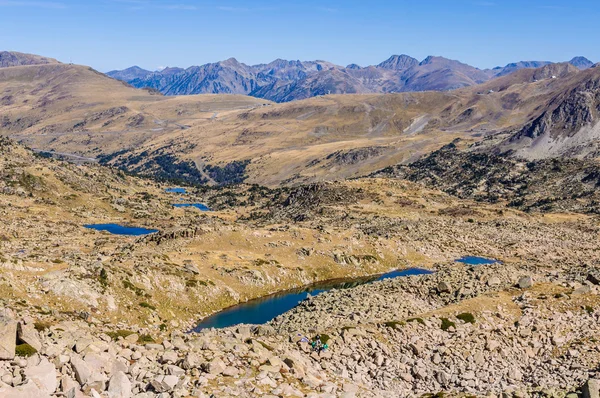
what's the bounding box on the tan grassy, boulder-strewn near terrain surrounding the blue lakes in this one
[0,139,600,398]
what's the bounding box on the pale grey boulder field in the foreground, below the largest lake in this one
[0,263,600,398]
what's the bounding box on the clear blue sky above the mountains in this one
[0,0,600,72]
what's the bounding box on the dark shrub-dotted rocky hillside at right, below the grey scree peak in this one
[373,144,600,214]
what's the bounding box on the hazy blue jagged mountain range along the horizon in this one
[107,55,594,102]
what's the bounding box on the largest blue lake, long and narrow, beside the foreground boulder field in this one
[193,268,433,332]
